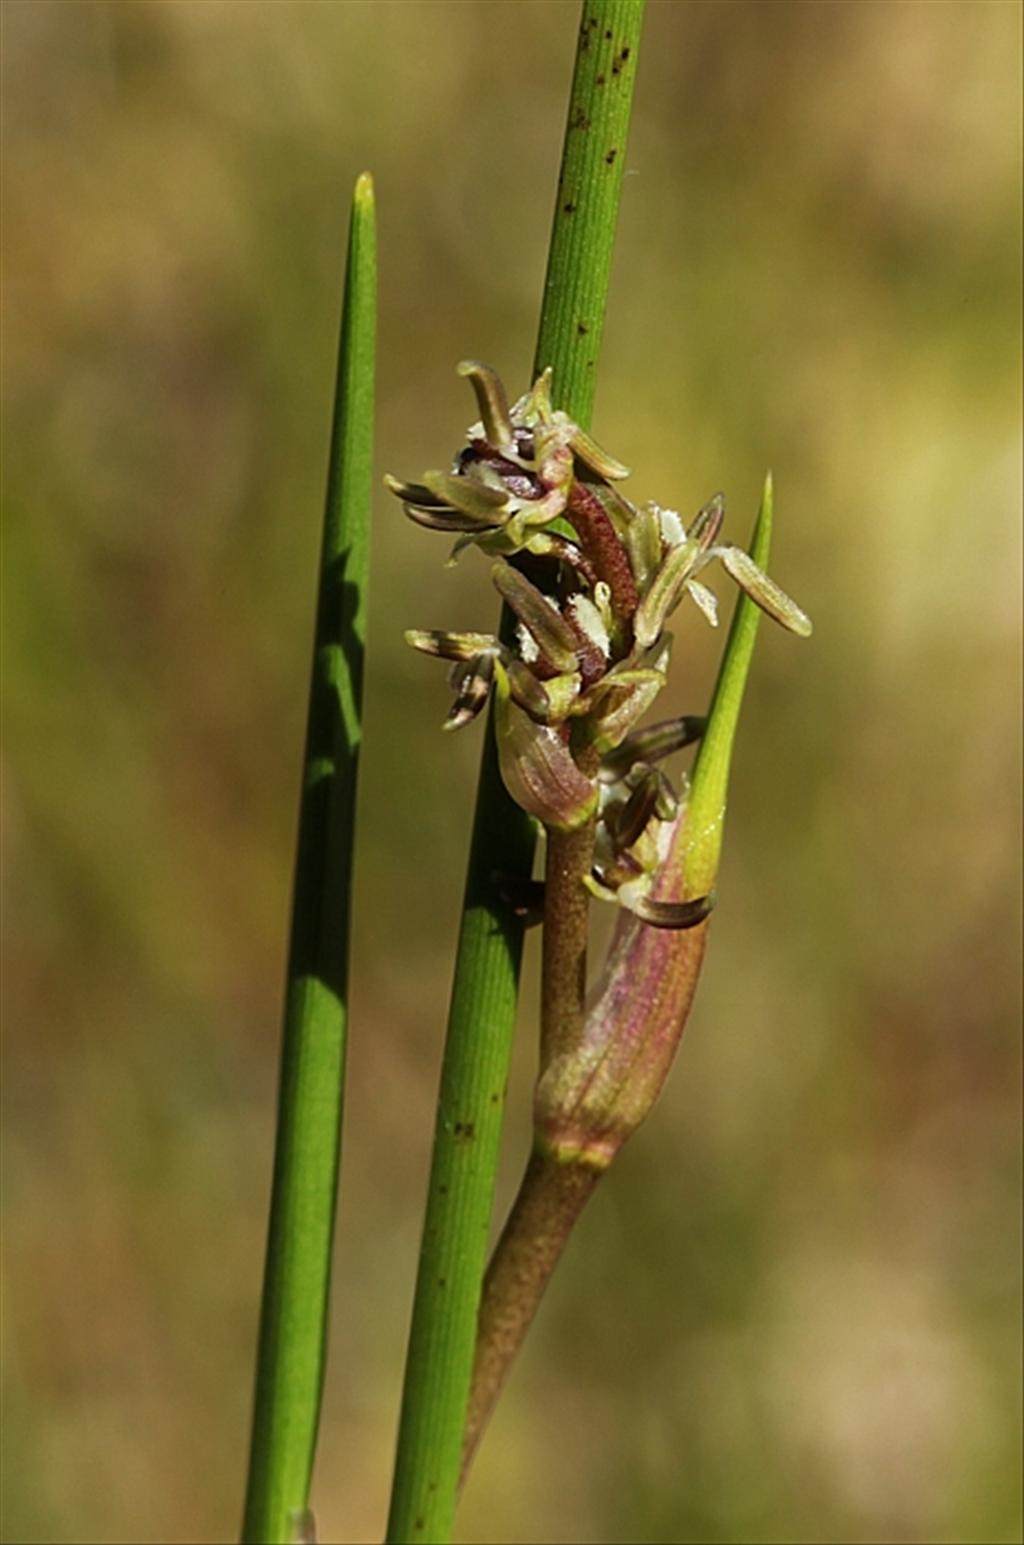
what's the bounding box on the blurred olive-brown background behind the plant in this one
[3,0,1021,1542]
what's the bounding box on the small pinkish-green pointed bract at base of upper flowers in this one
[494,661,598,831]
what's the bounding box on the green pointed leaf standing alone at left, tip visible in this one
[242,173,377,1545]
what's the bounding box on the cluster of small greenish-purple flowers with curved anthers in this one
[385,360,811,929]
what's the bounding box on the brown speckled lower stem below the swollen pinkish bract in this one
[462,1151,604,1480]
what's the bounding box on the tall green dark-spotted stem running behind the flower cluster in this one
[388,0,643,1545]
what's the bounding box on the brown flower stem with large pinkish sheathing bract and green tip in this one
[462,474,772,1479]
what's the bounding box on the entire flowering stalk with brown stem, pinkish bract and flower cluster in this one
[389,347,811,1475]
